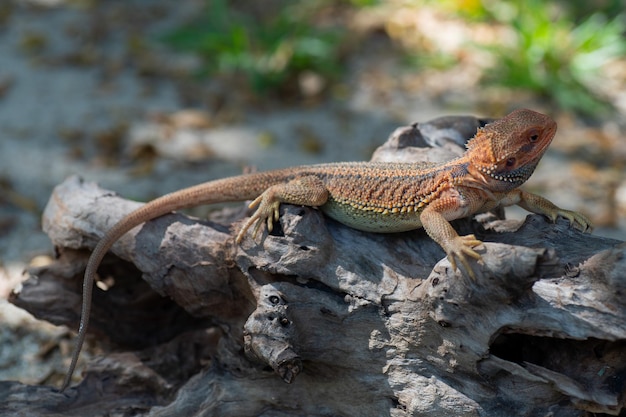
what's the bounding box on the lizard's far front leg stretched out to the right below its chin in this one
[501,189,593,232]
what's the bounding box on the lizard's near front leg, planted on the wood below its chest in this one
[420,198,482,278]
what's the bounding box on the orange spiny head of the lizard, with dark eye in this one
[467,109,556,191]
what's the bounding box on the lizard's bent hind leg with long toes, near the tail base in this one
[235,175,328,243]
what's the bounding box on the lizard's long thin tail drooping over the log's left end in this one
[61,169,293,392]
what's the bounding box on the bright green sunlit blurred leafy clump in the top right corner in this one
[483,0,626,114]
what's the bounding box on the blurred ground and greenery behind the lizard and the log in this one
[0,0,626,383]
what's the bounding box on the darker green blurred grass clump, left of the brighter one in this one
[164,0,344,93]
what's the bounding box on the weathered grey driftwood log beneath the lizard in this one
[0,118,626,417]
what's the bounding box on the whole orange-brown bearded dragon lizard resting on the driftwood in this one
[61,109,592,391]
